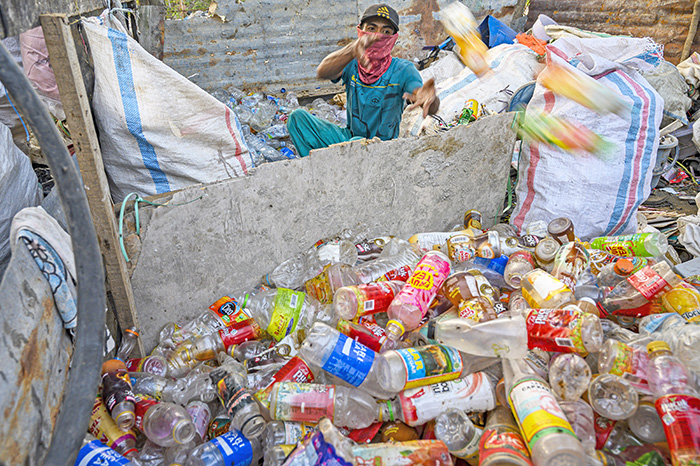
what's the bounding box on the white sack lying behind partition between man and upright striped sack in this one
[399,44,544,137]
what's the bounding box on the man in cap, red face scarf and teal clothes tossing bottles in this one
[287,4,440,157]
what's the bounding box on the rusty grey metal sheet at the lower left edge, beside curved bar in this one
[0,246,73,465]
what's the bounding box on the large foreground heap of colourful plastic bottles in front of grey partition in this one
[76,211,700,466]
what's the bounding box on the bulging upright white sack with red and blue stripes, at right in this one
[511,37,664,240]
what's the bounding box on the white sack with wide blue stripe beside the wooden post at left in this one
[83,19,253,202]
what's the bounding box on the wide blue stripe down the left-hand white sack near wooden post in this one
[107,29,171,193]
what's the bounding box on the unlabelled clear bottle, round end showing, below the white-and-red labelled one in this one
[435,409,483,464]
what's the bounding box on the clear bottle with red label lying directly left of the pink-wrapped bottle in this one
[333,280,404,320]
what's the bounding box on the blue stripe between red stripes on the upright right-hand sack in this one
[605,73,642,234]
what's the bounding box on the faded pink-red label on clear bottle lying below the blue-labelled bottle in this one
[270,382,335,422]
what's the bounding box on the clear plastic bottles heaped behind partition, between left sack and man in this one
[212,87,347,166]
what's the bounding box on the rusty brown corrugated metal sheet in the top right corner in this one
[526,0,700,64]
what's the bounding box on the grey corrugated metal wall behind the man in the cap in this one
[163,0,517,93]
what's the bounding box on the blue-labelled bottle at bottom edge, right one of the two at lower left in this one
[186,430,262,466]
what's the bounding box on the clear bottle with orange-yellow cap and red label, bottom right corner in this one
[647,341,700,466]
